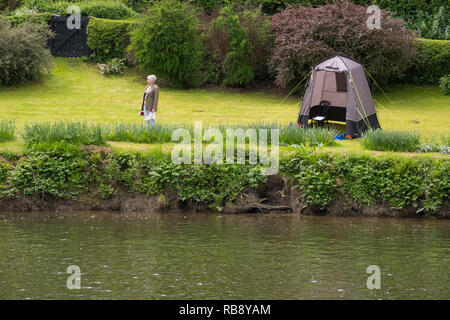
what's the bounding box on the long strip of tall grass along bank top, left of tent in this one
[17,122,338,148]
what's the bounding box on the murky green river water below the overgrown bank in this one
[0,212,450,299]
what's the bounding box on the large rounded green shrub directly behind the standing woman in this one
[130,0,203,88]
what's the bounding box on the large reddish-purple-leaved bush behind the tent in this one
[268,0,417,88]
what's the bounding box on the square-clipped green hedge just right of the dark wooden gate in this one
[86,18,136,63]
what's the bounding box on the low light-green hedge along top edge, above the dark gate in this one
[21,0,136,20]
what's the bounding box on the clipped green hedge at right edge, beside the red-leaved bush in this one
[408,39,450,85]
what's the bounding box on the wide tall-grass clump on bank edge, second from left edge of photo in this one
[22,122,106,148]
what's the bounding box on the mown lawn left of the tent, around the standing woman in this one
[0,58,299,129]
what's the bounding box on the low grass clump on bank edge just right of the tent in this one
[361,130,420,152]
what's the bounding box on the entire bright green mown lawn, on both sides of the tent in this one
[0,58,450,155]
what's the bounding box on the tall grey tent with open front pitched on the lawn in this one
[297,56,380,137]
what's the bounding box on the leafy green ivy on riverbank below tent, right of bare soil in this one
[280,152,450,214]
